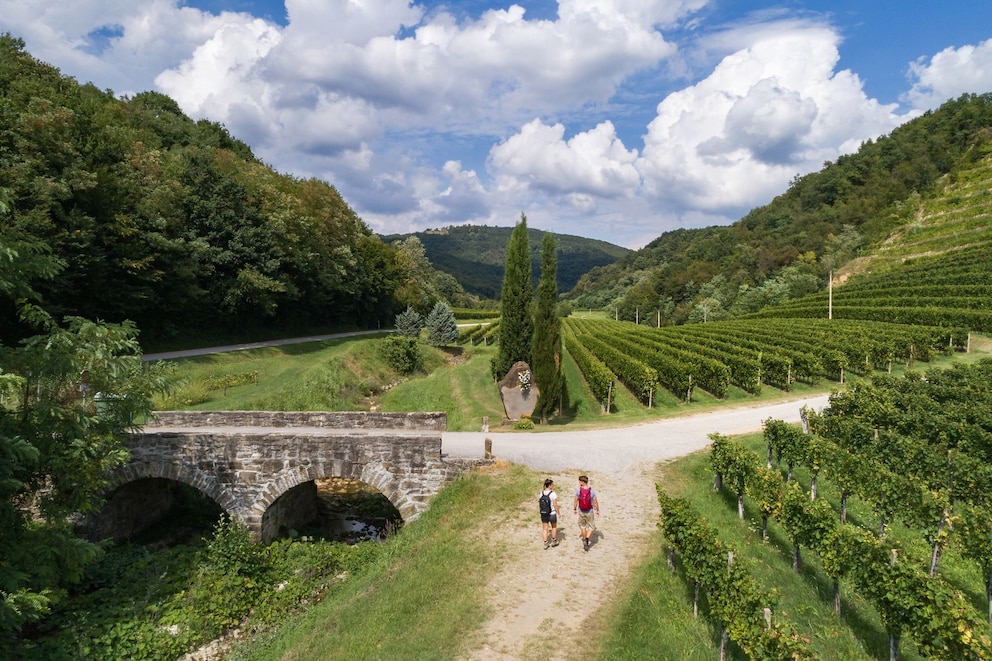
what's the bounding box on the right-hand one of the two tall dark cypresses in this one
[531,232,562,423]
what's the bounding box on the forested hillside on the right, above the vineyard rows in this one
[564,94,992,323]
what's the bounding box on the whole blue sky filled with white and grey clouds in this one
[0,0,992,249]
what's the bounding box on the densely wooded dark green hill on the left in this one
[0,35,458,344]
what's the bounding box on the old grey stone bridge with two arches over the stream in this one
[89,411,479,542]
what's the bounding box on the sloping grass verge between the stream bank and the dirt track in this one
[231,458,539,661]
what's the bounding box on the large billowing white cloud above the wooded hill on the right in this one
[637,23,906,213]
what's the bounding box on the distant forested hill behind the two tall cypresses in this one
[383,225,631,299]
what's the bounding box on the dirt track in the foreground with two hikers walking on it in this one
[465,462,660,661]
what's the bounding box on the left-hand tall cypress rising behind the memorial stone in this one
[493,214,540,376]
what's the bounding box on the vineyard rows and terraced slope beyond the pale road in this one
[552,144,992,407]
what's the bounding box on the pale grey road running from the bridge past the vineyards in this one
[441,395,829,474]
